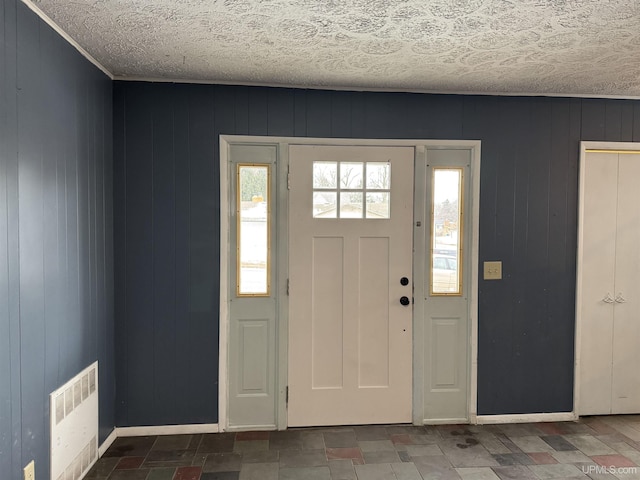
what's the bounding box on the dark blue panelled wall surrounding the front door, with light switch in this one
[114,82,640,425]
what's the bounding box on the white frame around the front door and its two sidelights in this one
[218,135,480,431]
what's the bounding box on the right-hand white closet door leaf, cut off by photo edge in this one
[608,154,640,413]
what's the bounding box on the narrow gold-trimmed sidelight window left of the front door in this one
[236,164,271,297]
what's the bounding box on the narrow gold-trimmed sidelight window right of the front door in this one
[429,168,464,295]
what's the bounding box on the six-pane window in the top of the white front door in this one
[313,161,391,219]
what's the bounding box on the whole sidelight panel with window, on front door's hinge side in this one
[228,145,277,429]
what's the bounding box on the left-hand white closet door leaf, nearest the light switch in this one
[577,153,618,415]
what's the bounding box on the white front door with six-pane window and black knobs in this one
[288,145,414,426]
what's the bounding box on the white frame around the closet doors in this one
[572,142,640,418]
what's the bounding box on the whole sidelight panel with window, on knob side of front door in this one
[423,149,471,422]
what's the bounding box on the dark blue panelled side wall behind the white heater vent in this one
[0,0,115,479]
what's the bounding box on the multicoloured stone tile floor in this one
[85,415,640,480]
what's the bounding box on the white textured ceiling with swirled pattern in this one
[25,0,640,97]
